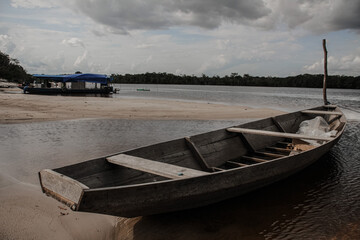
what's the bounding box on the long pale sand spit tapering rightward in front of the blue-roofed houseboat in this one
[0,90,281,124]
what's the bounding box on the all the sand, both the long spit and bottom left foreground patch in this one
[0,90,281,239]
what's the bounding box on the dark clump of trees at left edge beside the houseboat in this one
[0,51,32,83]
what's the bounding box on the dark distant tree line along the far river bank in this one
[112,73,360,89]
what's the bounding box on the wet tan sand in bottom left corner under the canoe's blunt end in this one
[0,173,117,240]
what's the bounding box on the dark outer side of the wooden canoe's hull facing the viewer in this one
[78,135,335,217]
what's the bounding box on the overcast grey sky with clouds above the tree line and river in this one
[0,0,360,76]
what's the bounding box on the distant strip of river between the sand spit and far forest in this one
[112,84,360,114]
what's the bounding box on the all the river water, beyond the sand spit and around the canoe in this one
[0,84,360,239]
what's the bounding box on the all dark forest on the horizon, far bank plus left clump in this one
[0,51,360,89]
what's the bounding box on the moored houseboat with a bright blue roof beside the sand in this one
[21,73,114,95]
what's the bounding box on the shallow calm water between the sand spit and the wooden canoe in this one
[0,119,242,184]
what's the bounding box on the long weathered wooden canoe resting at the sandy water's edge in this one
[39,105,346,217]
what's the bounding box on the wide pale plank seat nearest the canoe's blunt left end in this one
[106,154,209,179]
